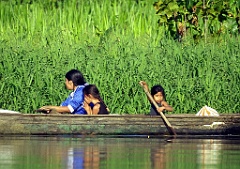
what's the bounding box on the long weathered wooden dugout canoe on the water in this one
[0,111,240,135]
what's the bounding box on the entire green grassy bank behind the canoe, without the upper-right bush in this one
[0,1,240,114]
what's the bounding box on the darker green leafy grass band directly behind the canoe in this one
[0,36,240,114]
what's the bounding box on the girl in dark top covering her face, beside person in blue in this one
[83,85,109,115]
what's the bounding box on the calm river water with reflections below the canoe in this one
[0,136,240,169]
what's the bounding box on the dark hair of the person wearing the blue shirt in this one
[65,69,86,86]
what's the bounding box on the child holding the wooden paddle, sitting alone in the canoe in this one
[139,81,173,115]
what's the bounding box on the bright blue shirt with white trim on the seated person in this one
[61,85,87,114]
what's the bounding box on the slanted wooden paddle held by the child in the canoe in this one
[140,83,177,135]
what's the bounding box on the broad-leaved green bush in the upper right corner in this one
[154,0,240,40]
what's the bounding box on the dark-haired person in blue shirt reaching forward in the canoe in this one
[40,69,87,114]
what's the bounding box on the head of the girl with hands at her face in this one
[83,84,101,104]
